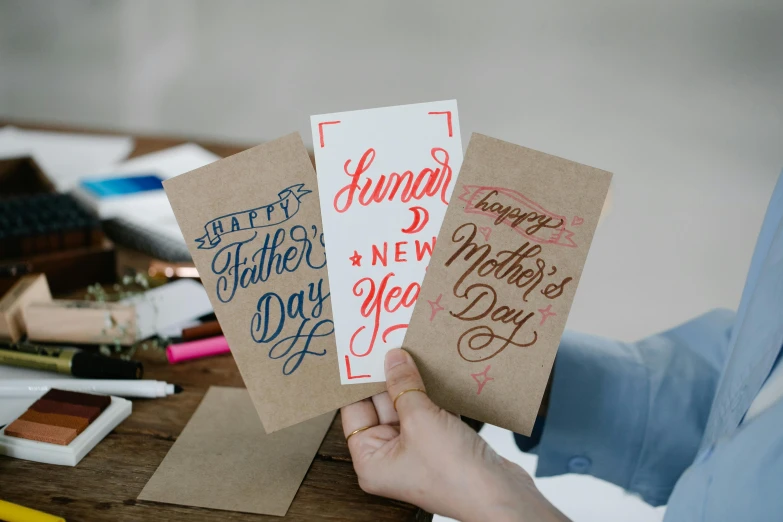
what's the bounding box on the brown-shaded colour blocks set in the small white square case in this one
[5,390,111,446]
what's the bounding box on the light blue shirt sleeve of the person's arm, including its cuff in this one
[536,310,734,506]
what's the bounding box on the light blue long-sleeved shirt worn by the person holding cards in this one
[536,169,783,522]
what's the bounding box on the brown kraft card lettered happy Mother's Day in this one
[405,134,612,434]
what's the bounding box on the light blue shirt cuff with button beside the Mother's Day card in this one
[536,332,649,489]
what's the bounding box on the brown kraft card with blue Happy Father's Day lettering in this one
[163,134,384,433]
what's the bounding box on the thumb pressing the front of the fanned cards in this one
[385,348,435,419]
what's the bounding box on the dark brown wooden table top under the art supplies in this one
[0,121,432,522]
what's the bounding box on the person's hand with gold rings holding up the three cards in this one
[341,349,566,522]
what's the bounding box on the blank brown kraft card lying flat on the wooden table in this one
[139,386,334,516]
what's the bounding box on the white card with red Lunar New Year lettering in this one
[311,100,462,384]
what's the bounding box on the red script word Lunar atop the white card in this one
[333,147,452,211]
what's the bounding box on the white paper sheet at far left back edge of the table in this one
[0,126,133,191]
